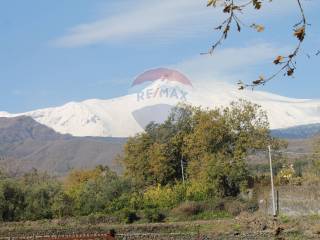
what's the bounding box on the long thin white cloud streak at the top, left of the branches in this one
[55,0,210,47]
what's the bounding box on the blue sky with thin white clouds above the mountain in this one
[0,0,320,112]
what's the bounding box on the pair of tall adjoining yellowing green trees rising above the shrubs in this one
[122,100,282,196]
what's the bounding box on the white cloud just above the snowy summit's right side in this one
[171,43,290,86]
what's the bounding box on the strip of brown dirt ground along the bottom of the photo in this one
[0,213,320,240]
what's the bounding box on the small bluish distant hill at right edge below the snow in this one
[272,123,320,139]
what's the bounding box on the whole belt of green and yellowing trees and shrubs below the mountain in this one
[0,101,310,223]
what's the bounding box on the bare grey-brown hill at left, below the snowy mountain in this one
[0,116,126,175]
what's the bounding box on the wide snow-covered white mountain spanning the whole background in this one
[0,78,320,137]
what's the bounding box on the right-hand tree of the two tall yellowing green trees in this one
[184,100,282,197]
